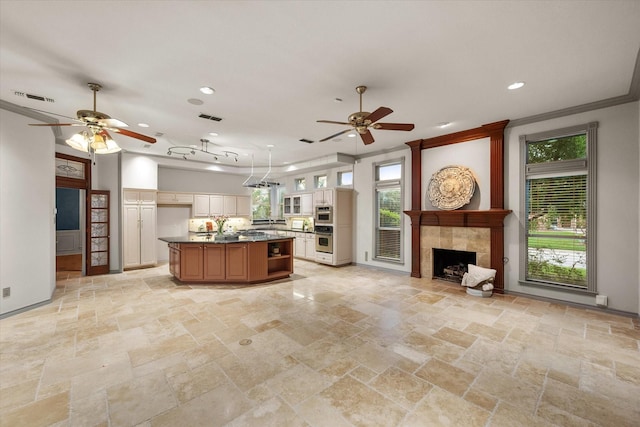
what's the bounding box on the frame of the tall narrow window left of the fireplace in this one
[371,157,405,264]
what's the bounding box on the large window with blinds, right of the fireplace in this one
[520,123,597,292]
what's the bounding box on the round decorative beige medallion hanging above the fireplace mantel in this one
[427,166,476,210]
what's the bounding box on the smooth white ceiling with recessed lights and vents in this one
[0,0,640,171]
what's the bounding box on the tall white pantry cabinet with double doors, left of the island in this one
[122,203,157,268]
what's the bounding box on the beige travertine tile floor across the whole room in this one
[0,260,640,427]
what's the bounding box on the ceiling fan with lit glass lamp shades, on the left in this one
[29,83,156,144]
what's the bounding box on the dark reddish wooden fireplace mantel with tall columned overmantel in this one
[404,120,511,292]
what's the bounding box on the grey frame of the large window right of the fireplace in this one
[518,122,598,294]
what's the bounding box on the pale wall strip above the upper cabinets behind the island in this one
[158,167,251,195]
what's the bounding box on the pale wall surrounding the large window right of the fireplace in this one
[505,102,640,313]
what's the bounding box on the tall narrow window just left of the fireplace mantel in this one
[374,161,403,262]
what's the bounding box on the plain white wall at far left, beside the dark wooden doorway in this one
[0,108,56,314]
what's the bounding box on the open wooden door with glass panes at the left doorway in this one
[87,190,110,276]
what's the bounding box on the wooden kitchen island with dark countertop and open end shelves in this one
[159,234,293,283]
